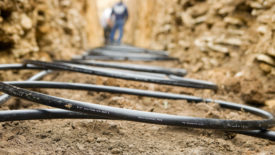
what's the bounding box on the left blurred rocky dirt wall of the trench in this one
[0,0,101,63]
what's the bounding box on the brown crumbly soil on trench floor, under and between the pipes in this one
[0,59,275,154]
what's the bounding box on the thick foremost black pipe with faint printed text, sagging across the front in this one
[0,83,275,130]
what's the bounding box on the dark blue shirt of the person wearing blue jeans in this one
[112,2,128,21]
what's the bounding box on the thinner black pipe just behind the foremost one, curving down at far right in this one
[2,81,273,119]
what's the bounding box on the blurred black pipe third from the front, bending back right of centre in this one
[0,61,217,89]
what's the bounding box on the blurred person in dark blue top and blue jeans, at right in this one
[110,0,128,44]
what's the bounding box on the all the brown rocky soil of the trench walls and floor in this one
[0,0,275,154]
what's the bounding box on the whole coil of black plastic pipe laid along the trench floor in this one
[0,46,275,141]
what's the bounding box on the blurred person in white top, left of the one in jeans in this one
[100,8,113,44]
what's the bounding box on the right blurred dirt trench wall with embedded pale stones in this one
[125,0,275,76]
